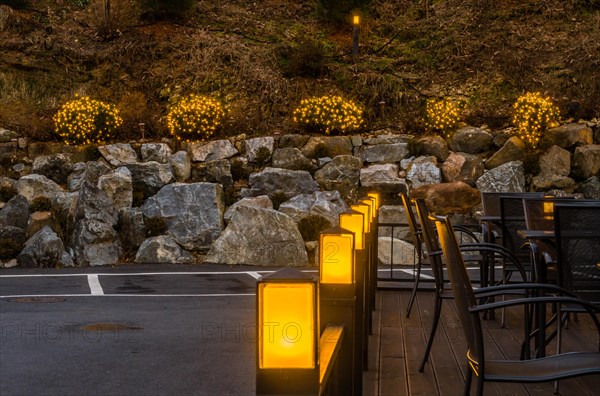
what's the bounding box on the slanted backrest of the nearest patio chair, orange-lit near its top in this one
[429,215,484,366]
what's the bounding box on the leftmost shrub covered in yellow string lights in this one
[53,95,123,145]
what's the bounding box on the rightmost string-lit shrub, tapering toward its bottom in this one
[512,92,559,148]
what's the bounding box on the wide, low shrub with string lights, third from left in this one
[292,95,364,134]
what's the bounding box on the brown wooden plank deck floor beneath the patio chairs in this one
[363,290,600,396]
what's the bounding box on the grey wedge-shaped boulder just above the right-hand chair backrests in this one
[476,161,525,192]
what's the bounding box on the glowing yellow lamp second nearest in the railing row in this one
[319,227,354,285]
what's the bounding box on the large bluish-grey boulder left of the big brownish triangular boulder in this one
[142,183,224,251]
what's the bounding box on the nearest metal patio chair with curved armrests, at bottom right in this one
[432,216,600,395]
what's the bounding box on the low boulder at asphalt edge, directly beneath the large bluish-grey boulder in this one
[135,235,194,264]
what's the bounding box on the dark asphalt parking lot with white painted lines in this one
[0,265,288,396]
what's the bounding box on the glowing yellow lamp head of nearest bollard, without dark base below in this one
[257,268,319,369]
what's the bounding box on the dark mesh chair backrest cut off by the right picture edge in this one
[554,200,600,303]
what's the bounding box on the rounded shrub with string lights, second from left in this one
[167,94,225,141]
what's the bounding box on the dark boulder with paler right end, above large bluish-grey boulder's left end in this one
[125,161,175,206]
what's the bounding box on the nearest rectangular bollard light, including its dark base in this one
[256,268,320,395]
